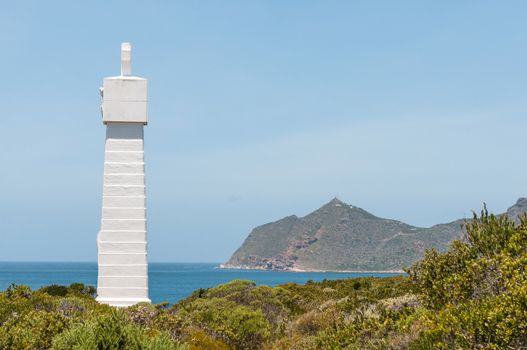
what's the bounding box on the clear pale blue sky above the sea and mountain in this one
[0,0,527,262]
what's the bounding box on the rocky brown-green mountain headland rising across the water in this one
[222,198,527,271]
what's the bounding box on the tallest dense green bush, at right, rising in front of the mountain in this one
[409,209,527,349]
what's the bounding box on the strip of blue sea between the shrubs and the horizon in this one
[0,262,402,303]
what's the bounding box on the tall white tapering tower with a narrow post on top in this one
[97,43,150,306]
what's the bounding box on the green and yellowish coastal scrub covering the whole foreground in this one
[0,211,527,350]
